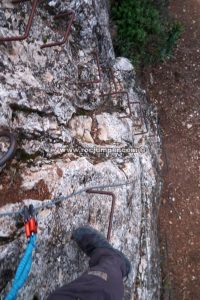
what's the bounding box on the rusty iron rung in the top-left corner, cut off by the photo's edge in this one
[0,0,39,42]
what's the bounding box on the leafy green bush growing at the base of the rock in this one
[111,0,182,65]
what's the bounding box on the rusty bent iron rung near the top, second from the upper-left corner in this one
[41,11,75,49]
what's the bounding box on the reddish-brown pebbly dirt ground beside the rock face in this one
[142,0,200,300]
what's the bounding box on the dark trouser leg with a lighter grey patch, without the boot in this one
[47,248,125,300]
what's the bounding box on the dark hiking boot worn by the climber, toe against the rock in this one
[72,226,131,277]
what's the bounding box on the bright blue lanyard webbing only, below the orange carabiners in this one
[5,234,36,300]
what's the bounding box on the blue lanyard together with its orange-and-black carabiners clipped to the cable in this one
[5,205,37,300]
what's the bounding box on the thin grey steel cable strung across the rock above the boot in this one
[0,181,133,218]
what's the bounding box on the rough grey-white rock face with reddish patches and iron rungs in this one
[0,0,161,300]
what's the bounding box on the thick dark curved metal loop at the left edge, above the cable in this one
[0,130,17,168]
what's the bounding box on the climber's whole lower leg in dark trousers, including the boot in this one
[48,227,130,300]
